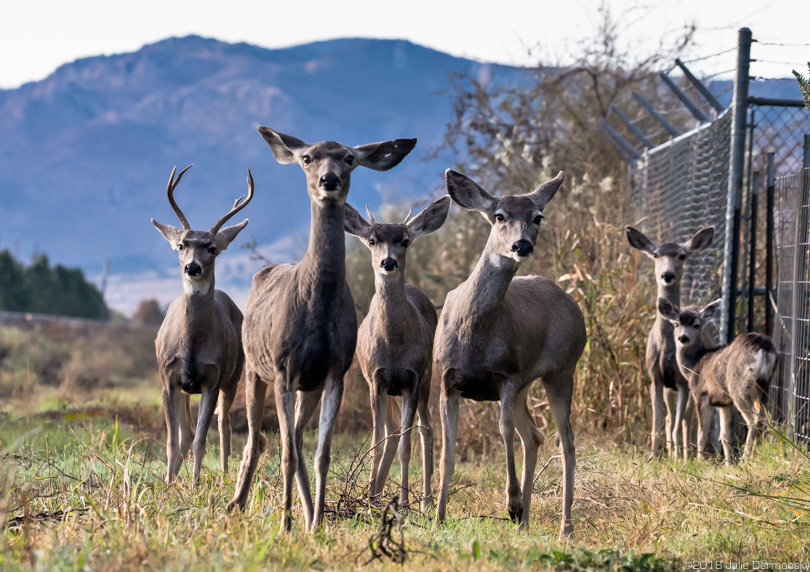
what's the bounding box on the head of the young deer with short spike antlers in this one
[343,195,450,275]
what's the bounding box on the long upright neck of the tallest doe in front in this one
[300,201,346,296]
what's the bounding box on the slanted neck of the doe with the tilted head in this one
[463,234,520,322]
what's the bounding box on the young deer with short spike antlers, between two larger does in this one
[344,195,450,512]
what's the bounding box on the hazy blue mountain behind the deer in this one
[0,36,525,306]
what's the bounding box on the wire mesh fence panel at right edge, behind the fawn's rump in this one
[769,168,810,441]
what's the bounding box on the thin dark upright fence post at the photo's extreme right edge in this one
[785,135,810,439]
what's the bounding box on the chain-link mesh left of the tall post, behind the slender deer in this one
[633,112,732,305]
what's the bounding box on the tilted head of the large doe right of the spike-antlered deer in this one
[445,169,565,262]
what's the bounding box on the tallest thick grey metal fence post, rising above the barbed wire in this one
[723,28,751,343]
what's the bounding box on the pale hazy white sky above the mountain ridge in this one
[0,0,810,88]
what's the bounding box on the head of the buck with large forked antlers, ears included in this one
[152,165,253,294]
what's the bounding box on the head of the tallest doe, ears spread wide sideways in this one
[259,127,416,204]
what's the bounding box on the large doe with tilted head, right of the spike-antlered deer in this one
[433,170,587,540]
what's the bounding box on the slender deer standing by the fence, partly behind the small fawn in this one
[625,226,714,459]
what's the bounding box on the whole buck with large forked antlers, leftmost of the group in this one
[152,165,253,484]
